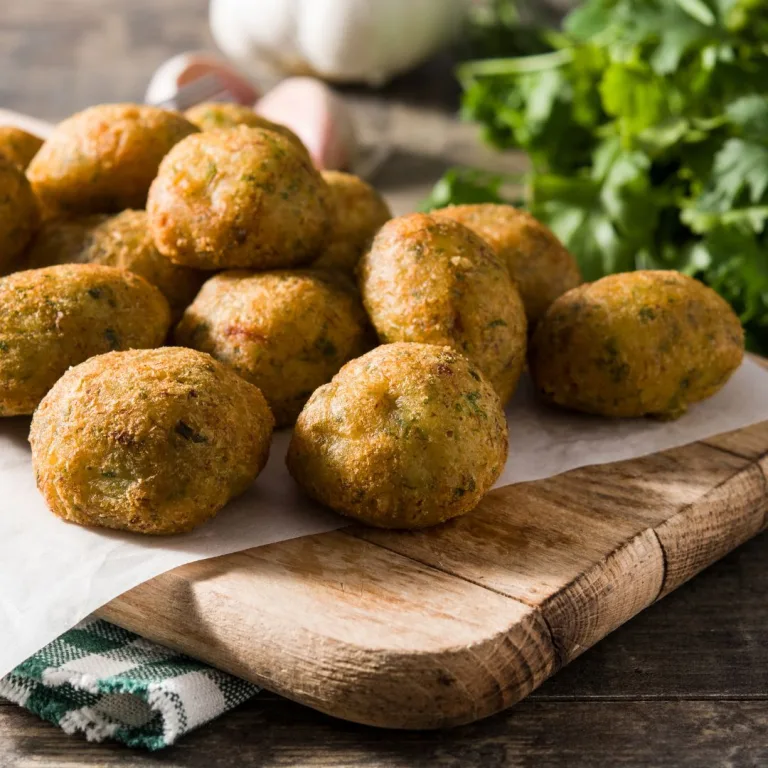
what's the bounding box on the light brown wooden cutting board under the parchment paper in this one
[100,422,768,728]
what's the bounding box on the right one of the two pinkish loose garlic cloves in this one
[255,77,358,171]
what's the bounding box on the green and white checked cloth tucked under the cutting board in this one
[0,619,259,750]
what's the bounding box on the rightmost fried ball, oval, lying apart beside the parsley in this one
[530,271,744,418]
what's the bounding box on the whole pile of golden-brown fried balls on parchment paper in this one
[0,104,744,534]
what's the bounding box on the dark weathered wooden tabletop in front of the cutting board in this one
[6,535,768,768]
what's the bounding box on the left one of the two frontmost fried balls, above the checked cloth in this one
[29,347,273,534]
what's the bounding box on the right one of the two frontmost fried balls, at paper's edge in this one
[287,343,507,528]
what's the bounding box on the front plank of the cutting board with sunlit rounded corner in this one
[100,533,555,728]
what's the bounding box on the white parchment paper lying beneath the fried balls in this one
[0,361,768,676]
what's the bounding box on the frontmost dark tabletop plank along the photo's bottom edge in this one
[0,697,768,768]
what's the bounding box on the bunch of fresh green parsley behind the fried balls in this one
[433,0,768,351]
